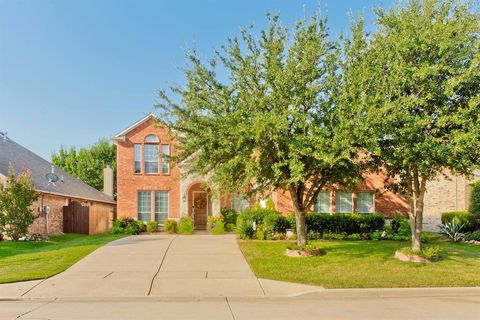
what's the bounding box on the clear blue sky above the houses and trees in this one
[0,0,394,160]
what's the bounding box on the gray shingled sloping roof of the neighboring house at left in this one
[0,132,115,203]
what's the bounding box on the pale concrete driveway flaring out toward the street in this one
[0,233,321,298]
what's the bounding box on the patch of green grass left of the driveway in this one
[0,234,123,283]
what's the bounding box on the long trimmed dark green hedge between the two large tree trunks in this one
[306,213,385,234]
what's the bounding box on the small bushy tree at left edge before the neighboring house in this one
[0,168,38,241]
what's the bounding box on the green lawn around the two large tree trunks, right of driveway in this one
[239,240,480,288]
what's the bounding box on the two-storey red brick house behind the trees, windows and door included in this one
[113,114,408,229]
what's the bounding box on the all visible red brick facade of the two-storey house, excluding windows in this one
[114,116,408,220]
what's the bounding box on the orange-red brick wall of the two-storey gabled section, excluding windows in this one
[117,119,181,219]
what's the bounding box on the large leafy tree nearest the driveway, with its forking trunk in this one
[158,16,361,246]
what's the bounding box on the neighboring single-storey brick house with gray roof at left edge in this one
[0,133,115,234]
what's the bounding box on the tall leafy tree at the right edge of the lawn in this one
[355,0,480,250]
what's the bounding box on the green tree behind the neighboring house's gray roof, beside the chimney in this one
[52,140,117,194]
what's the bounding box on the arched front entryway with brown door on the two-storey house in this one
[188,182,212,230]
